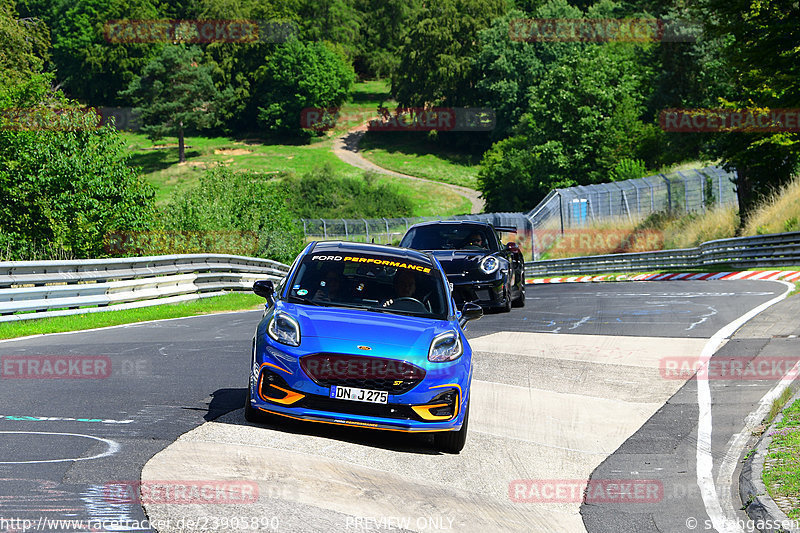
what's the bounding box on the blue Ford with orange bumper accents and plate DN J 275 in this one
[245,242,483,453]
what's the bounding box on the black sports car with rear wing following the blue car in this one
[400,221,525,311]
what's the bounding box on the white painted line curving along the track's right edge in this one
[697,281,794,533]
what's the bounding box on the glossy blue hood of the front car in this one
[281,302,456,357]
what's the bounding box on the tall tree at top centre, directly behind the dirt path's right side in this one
[392,0,506,107]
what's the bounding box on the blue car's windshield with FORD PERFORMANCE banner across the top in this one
[287,253,448,320]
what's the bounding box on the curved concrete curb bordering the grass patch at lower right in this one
[739,392,800,533]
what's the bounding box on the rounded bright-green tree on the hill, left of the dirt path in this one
[253,38,355,133]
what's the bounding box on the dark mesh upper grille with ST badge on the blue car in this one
[300,353,425,394]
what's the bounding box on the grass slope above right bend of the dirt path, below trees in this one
[360,132,480,190]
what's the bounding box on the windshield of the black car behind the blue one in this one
[400,224,497,252]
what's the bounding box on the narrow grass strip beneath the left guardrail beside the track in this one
[0,292,264,339]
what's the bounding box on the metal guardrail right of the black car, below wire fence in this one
[525,232,800,276]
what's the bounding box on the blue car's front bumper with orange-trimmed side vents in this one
[249,342,471,432]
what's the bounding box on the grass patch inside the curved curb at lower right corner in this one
[762,394,800,520]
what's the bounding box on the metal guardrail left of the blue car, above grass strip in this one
[0,254,289,322]
